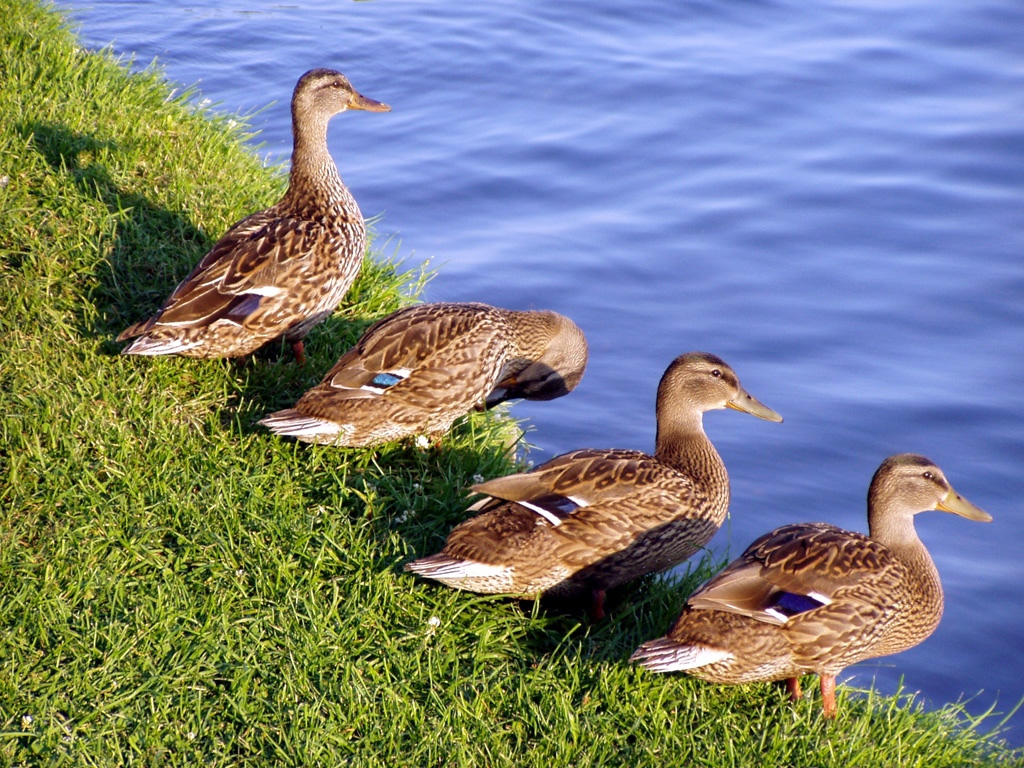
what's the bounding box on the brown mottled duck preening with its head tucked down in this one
[260,303,587,445]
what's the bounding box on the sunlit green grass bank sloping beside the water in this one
[0,0,1022,768]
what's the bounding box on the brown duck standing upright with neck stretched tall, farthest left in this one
[118,70,391,362]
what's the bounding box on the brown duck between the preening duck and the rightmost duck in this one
[406,352,782,618]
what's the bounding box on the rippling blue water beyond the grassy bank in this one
[62,0,1024,744]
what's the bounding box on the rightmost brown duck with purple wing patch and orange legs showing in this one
[633,454,992,718]
